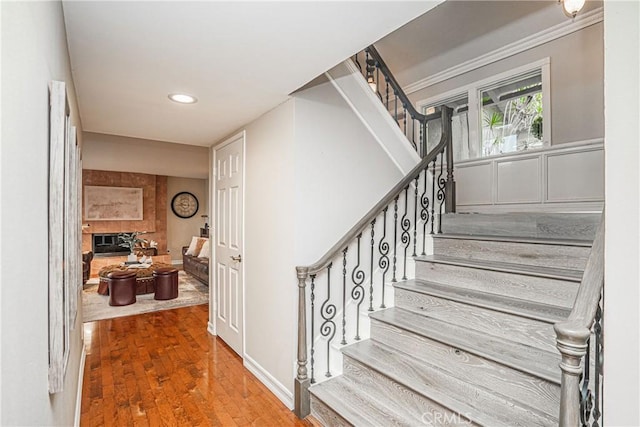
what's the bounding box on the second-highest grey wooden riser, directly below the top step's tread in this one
[433,237,591,270]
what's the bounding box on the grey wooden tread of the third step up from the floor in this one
[369,308,560,384]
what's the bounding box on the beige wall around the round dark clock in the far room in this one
[167,176,211,262]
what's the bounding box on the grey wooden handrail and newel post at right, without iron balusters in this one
[553,211,605,427]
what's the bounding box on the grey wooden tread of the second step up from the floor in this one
[342,340,557,426]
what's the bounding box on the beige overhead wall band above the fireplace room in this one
[82,132,209,179]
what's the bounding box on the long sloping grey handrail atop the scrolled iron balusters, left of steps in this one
[296,107,451,274]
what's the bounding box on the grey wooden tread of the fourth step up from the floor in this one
[393,279,571,323]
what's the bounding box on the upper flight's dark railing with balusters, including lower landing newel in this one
[353,45,456,212]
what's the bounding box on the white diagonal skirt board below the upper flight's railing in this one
[325,59,420,174]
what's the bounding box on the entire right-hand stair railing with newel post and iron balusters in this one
[554,212,604,427]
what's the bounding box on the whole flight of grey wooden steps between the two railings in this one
[309,214,600,426]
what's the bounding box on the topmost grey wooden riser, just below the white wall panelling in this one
[442,213,600,240]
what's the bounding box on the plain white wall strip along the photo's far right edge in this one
[603,1,640,426]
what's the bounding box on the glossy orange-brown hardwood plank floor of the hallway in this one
[80,305,311,427]
